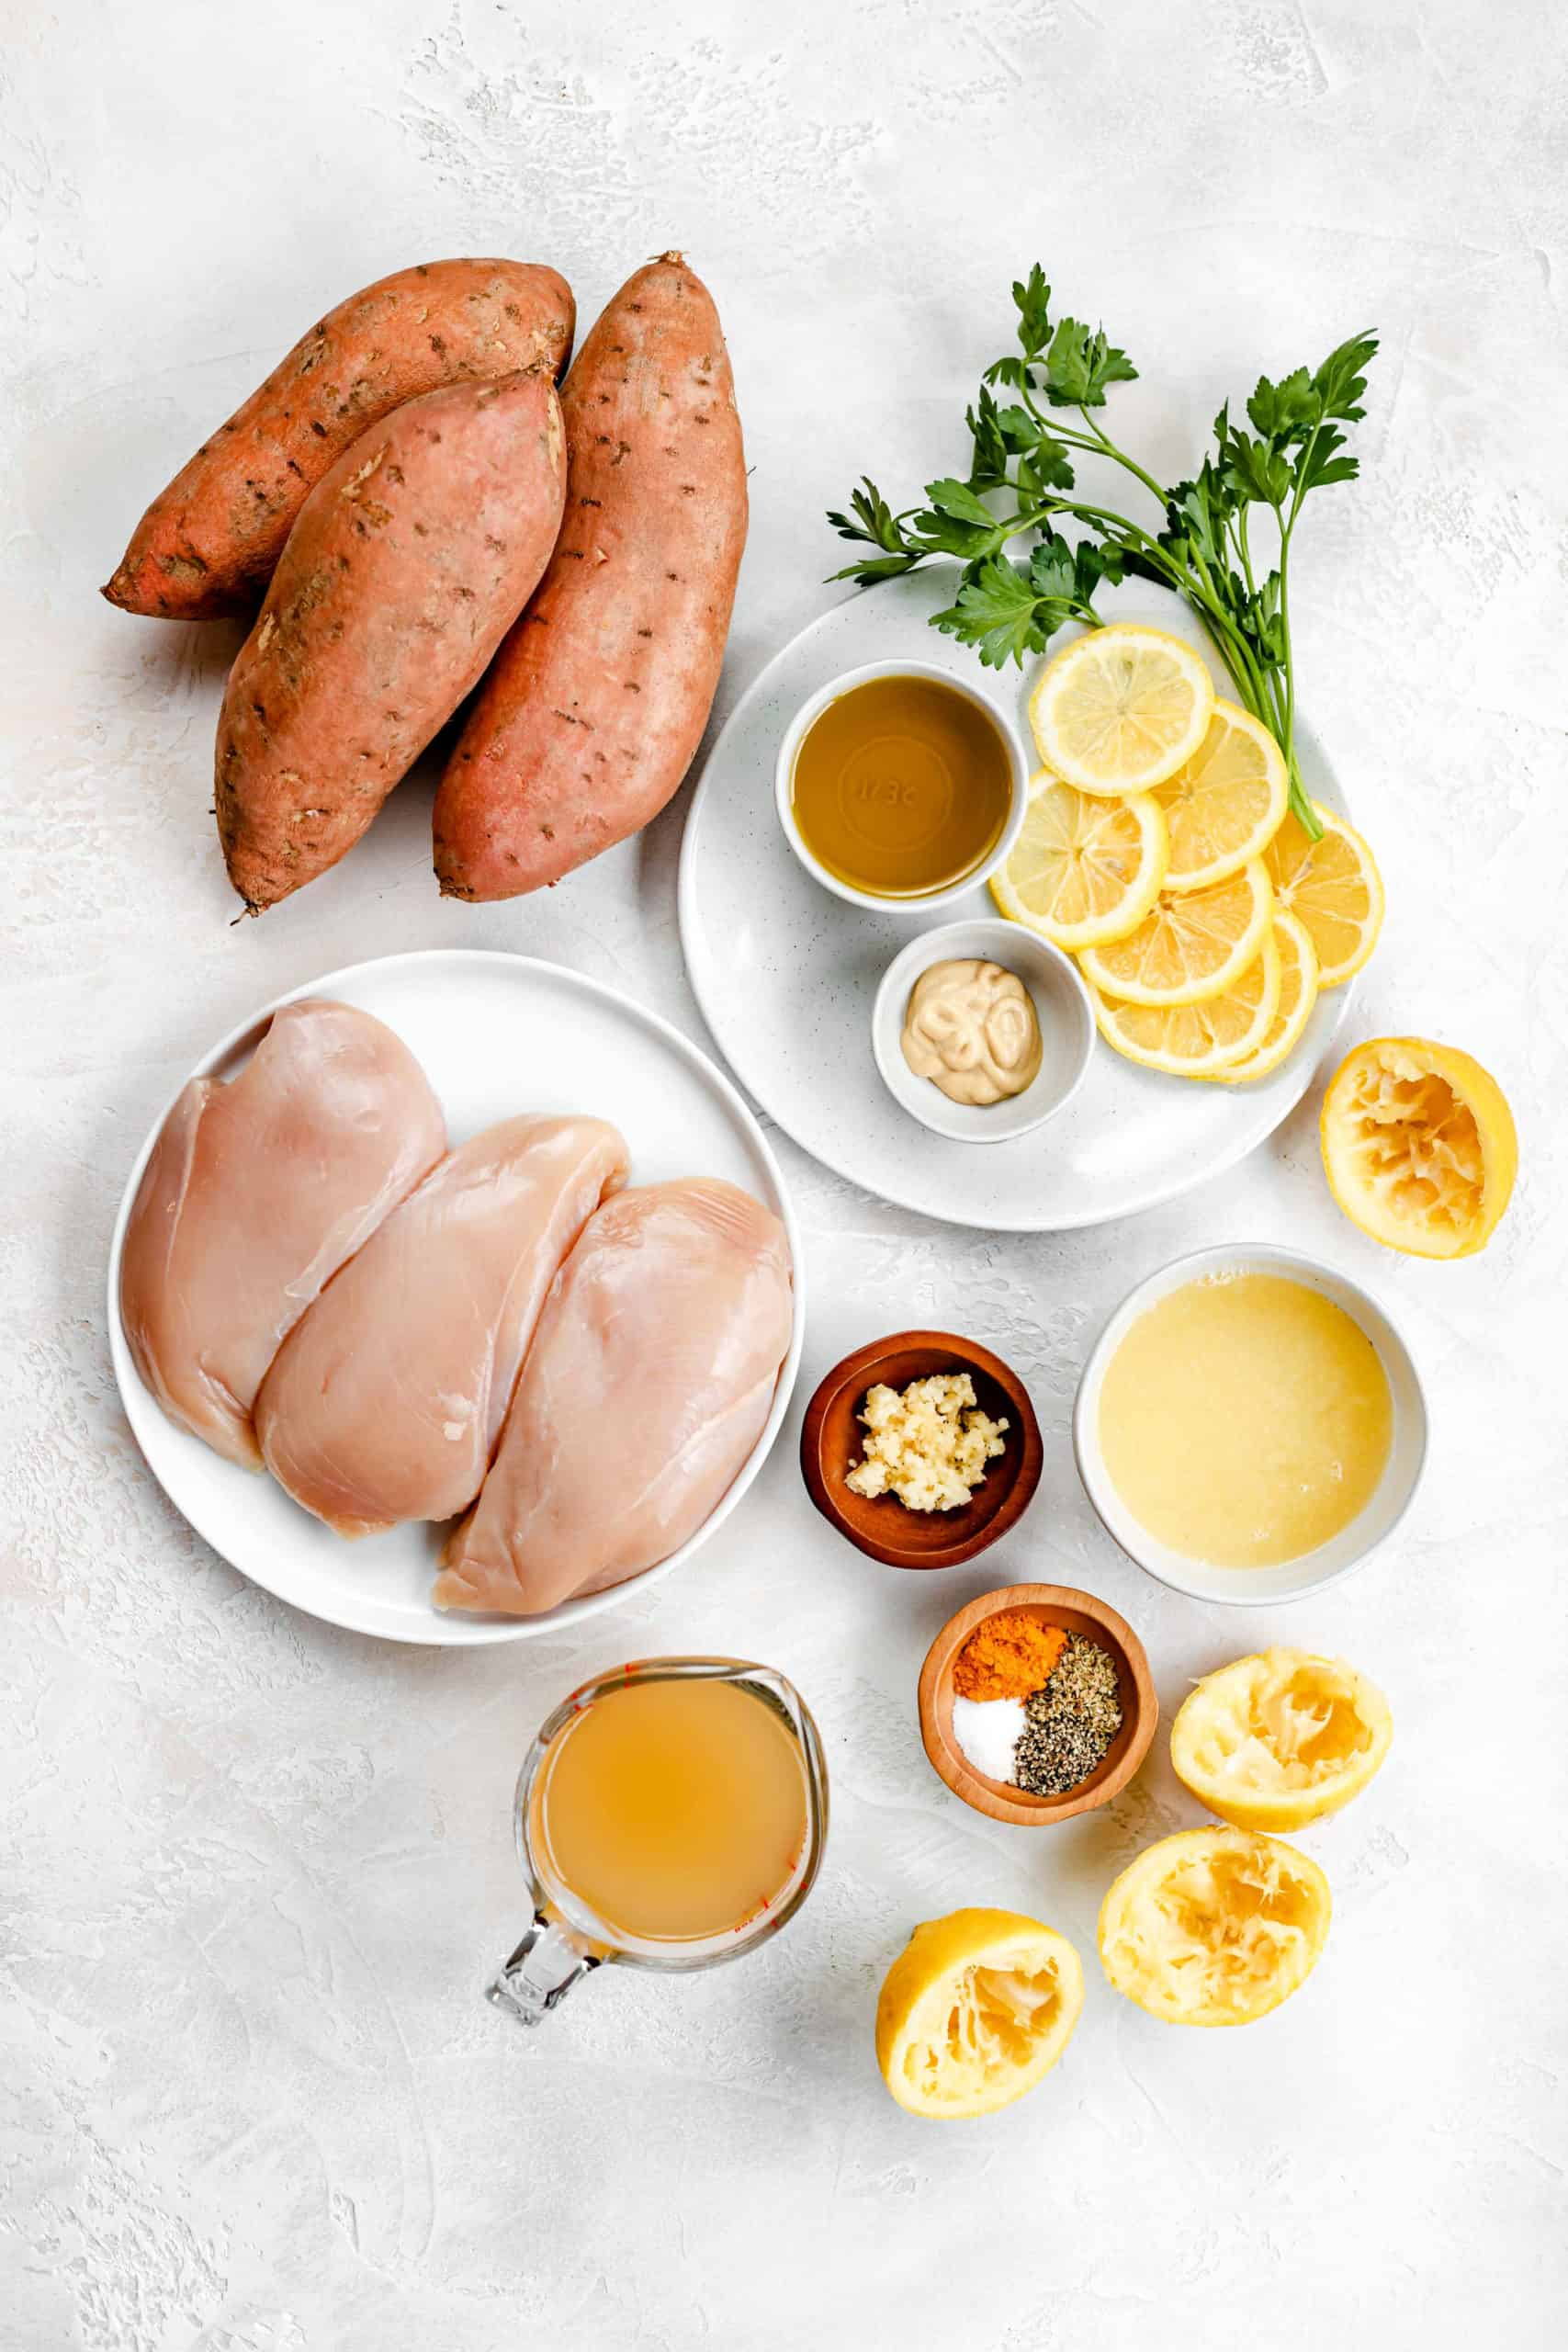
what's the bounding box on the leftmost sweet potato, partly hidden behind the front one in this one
[104,261,576,621]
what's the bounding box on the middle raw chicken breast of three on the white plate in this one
[256,1117,626,1536]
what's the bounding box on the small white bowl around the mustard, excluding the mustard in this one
[872,915,1096,1143]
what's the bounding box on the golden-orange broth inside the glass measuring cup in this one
[529,1675,808,1943]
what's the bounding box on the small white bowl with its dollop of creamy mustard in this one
[872,915,1096,1143]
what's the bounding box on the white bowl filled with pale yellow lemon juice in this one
[1072,1242,1427,1606]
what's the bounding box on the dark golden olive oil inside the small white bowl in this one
[790,677,1013,899]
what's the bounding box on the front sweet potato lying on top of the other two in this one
[216,369,567,912]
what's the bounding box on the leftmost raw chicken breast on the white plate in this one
[120,997,446,1467]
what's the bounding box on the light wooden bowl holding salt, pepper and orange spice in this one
[919,1585,1159,1830]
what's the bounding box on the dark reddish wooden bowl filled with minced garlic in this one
[799,1331,1043,1569]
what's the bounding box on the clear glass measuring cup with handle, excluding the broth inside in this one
[487,1658,828,2025]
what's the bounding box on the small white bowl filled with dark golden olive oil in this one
[773,661,1030,915]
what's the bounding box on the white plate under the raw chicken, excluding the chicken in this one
[108,945,807,1646]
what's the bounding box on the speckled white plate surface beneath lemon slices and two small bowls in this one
[680,564,1349,1232]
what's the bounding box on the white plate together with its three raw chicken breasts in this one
[108,948,804,1644]
